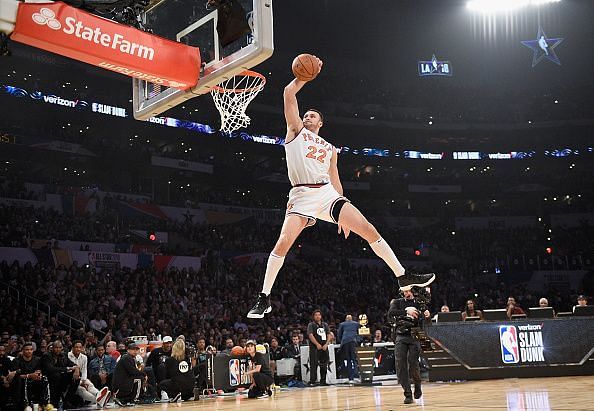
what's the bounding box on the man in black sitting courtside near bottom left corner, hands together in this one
[10,342,49,409]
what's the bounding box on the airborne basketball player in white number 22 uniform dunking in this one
[248,57,435,318]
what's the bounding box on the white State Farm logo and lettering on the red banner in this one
[32,7,155,60]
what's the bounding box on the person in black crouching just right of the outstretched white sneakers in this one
[112,343,146,405]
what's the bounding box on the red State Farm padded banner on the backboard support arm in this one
[11,2,200,89]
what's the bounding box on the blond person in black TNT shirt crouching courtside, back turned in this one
[159,339,196,402]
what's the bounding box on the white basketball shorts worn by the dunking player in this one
[287,183,350,227]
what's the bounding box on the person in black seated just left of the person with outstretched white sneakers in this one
[41,340,83,408]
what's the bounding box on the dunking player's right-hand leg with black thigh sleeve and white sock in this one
[332,200,435,290]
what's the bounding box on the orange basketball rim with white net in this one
[210,70,266,133]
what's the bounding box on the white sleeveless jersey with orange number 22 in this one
[285,127,334,187]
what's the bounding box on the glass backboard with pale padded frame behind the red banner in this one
[132,0,274,120]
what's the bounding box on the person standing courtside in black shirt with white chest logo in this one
[307,310,330,385]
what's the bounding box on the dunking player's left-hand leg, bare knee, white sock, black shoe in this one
[248,214,308,318]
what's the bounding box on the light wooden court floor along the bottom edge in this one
[128,376,594,411]
